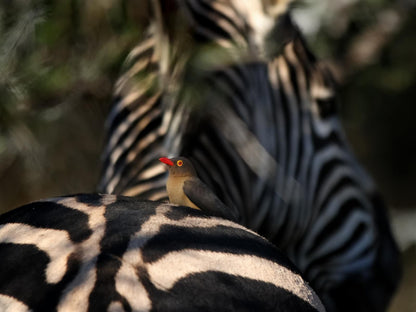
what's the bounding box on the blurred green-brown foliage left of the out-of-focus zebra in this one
[0,0,148,211]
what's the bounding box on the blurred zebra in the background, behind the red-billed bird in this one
[99,0,401,311]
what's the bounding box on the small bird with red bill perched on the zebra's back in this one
[159,156,238,222]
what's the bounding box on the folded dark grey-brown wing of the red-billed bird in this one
[183,178,238,221]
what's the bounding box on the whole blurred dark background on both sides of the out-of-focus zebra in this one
[0,0,416,311]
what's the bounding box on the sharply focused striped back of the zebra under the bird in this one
[0,194,325,312]
